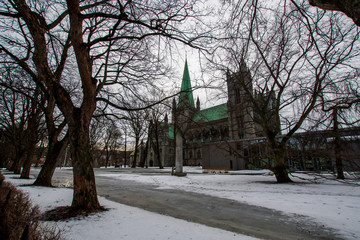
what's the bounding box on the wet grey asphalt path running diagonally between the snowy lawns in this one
[53,169,342,240]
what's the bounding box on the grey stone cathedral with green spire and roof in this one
[146,61,261,170]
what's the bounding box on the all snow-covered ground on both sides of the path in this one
[2,168,360,240]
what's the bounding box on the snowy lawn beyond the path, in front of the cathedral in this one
[98,168,360,239]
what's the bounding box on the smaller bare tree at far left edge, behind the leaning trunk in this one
[0,68,44,178]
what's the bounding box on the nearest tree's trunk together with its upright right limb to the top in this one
[64,0,101,212]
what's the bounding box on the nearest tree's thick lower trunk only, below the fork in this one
[69,116,101,212]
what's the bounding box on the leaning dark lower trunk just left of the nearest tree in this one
[33,138,68,187]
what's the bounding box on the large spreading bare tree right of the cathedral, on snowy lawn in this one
[214,0,359,182]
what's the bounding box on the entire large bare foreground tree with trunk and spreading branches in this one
[0,0,207,211]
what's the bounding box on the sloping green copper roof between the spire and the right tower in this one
[193,103,228,122]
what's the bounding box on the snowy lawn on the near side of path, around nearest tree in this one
[5,171,255,240]
